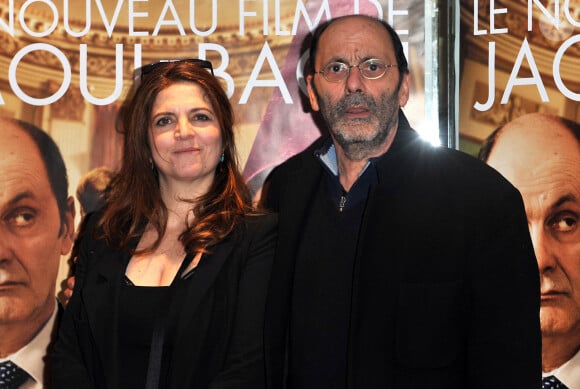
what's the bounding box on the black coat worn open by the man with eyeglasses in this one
[264,112,541,389]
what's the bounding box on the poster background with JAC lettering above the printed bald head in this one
[458,0,580,155]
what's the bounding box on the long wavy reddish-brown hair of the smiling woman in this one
[99,61,252,254]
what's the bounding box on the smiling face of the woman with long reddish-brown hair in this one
[149,81,223,194]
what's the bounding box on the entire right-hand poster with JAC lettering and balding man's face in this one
[459,0,580,372]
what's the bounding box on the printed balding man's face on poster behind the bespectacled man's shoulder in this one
[488,114,580,341]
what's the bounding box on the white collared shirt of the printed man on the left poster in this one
[0,303,58,389]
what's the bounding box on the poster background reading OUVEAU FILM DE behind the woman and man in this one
[0,0,426,294]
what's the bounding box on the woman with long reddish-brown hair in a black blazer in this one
[53,59,276,389]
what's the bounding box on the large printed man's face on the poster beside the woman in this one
[0,123,74,326]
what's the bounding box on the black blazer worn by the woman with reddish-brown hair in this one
[53,214,277,389]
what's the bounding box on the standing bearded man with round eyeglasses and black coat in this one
[263,15,541,389]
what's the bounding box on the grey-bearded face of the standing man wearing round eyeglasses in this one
[307,18,409,159]
